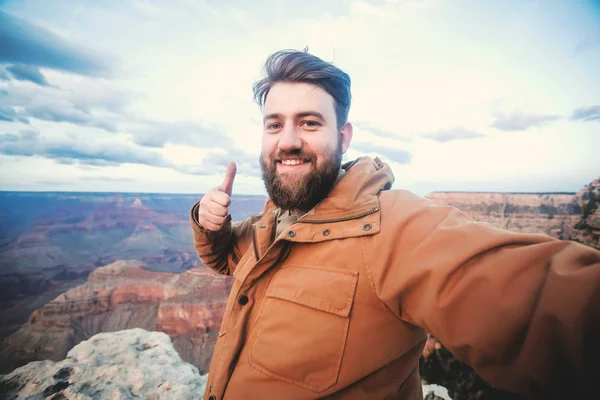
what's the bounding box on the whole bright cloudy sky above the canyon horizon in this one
[0,0,600,195]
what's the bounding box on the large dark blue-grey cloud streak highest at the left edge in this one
[0,11,110,76]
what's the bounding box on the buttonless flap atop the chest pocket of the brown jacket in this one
[266,265,358,317]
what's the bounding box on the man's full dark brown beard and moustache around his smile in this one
[260,144,342,211]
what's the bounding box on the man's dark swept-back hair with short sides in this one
[252,48,352,129]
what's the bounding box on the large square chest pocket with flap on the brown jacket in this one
[250,265,358,392]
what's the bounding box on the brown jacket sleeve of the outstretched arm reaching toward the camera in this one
[372,190,600,399]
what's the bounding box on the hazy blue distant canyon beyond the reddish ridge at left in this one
[0,192,265,341]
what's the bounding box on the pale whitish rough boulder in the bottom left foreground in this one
[0,329,206,400]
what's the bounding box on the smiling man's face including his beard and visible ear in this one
[260,82,352,211]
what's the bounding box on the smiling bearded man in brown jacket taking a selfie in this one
[191,51,600,400]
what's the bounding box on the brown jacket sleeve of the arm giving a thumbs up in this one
[190,203,262,275]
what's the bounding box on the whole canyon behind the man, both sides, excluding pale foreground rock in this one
[0,179,600,399]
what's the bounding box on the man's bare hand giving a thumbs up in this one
[198,161,237,231]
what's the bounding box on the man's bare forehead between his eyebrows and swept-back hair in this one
[263,82,335,117]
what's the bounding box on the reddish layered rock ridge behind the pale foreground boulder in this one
[0,261,232,372]
